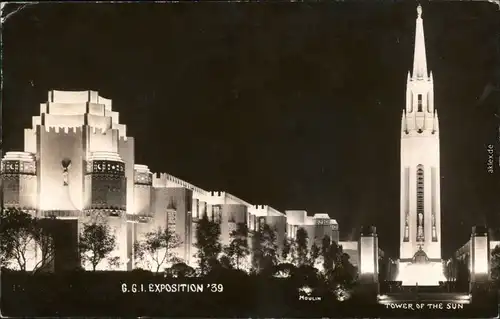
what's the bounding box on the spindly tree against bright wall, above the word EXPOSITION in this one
[134,227,182,272]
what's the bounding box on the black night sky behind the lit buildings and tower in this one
[3,1,500,256]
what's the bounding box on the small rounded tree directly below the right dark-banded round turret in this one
[79,222,116,271]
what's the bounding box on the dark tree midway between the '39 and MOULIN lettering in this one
[252,224,278,273]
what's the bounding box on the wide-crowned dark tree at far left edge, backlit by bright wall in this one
[0,209,54,272]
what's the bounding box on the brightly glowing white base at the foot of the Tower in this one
[396,262,446,286]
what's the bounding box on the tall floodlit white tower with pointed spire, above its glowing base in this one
[400,5,441,262]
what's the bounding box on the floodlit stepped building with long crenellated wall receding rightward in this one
[1,91,338,270]
